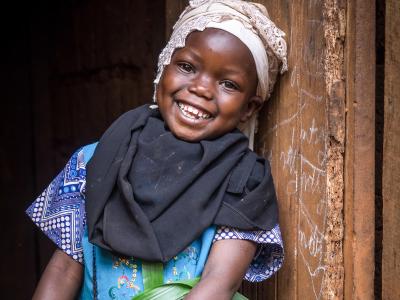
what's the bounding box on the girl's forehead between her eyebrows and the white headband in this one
[183,28,255,71]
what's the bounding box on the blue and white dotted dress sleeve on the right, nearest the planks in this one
[213,224,284,282]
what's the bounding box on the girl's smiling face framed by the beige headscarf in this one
[157,28,262,142]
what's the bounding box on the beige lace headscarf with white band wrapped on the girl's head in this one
[154,0,287,149]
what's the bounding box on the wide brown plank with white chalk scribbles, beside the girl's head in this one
[258,1,334,299]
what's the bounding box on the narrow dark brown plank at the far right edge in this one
[382,0,400,300]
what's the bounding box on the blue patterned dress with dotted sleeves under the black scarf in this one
[27,144,283,299]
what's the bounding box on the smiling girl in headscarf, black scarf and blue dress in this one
[27,0,286,299]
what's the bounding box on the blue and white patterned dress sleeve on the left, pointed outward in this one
[26,149,86,263]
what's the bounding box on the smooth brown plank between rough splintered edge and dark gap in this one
[344,0,375,299]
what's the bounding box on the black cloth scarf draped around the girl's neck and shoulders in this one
[86,105,278,262]
